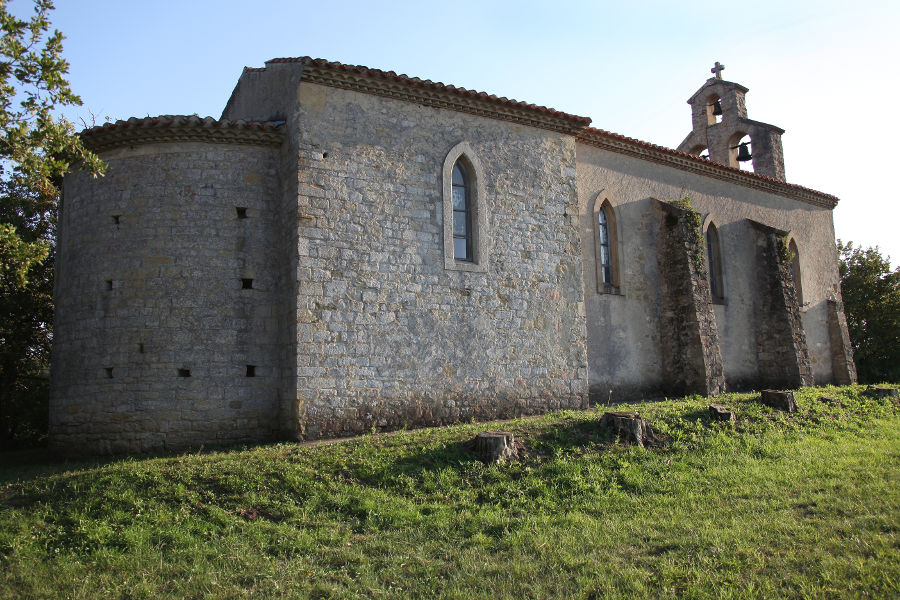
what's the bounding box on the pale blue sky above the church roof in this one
[26,0,900,266]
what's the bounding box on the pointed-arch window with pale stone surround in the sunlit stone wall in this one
[443,142,489,272]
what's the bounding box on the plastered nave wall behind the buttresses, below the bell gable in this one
[577,142,852,392]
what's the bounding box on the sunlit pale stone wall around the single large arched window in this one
[284,83,587,438]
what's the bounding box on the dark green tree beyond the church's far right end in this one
[838,240,900,383]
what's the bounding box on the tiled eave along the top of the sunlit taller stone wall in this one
[266,57,591,135]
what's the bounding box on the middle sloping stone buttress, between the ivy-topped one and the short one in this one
[750,221,814,389]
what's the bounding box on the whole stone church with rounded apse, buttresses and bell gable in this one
[50,58,855,452]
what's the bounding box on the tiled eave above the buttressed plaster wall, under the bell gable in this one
[577,128,838,209]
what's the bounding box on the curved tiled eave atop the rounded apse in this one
[79,115,283,152]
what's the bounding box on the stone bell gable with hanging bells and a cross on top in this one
[678,62,785,181]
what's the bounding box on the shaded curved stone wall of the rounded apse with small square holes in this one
[50,142,282,452]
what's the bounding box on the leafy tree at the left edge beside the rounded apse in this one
[0,0,104,448]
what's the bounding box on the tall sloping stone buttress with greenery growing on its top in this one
[653,200,725,396]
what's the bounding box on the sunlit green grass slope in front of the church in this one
[0,387,900,598]
